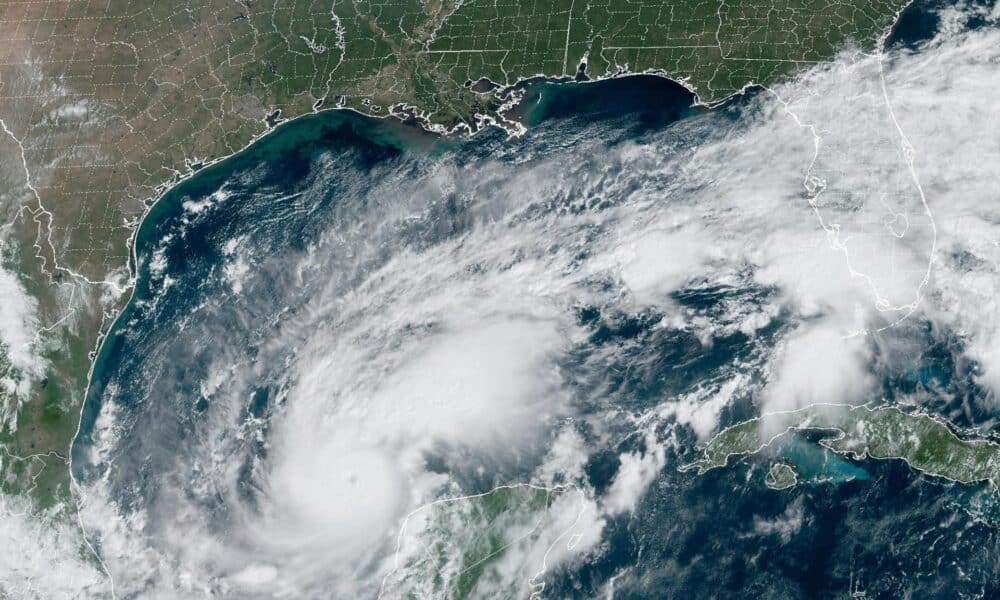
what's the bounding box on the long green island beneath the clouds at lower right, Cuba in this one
[684,404,1000,489]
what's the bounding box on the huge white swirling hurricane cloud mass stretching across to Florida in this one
[68,7,1000,597]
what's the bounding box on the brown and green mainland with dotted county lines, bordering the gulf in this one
[0,0,984,592]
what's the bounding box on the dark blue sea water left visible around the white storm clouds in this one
[73,10,1000,598]
